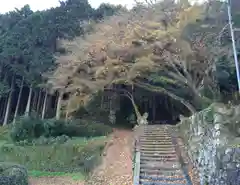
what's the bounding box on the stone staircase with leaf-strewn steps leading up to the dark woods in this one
[134,125,190,185]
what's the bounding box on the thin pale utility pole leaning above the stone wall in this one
[227,0,240,93]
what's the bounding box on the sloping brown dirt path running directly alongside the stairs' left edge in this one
[86,130,133,185]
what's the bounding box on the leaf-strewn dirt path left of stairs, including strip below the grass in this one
[30,129,133,185]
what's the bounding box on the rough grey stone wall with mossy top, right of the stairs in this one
[178,103,240,185]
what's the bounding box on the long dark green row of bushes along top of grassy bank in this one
[10,117,112,143]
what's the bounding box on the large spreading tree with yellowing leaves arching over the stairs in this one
[50,1,227,121]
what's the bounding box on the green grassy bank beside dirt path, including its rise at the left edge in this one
[0,128,108,174]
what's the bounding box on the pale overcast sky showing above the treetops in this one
[0,0,138,13]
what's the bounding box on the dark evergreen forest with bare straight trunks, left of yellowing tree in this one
[0,0,122,125]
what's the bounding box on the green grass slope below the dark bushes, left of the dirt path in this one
[0,138,105,172]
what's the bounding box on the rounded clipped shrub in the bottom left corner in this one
[0,162,28,185]
